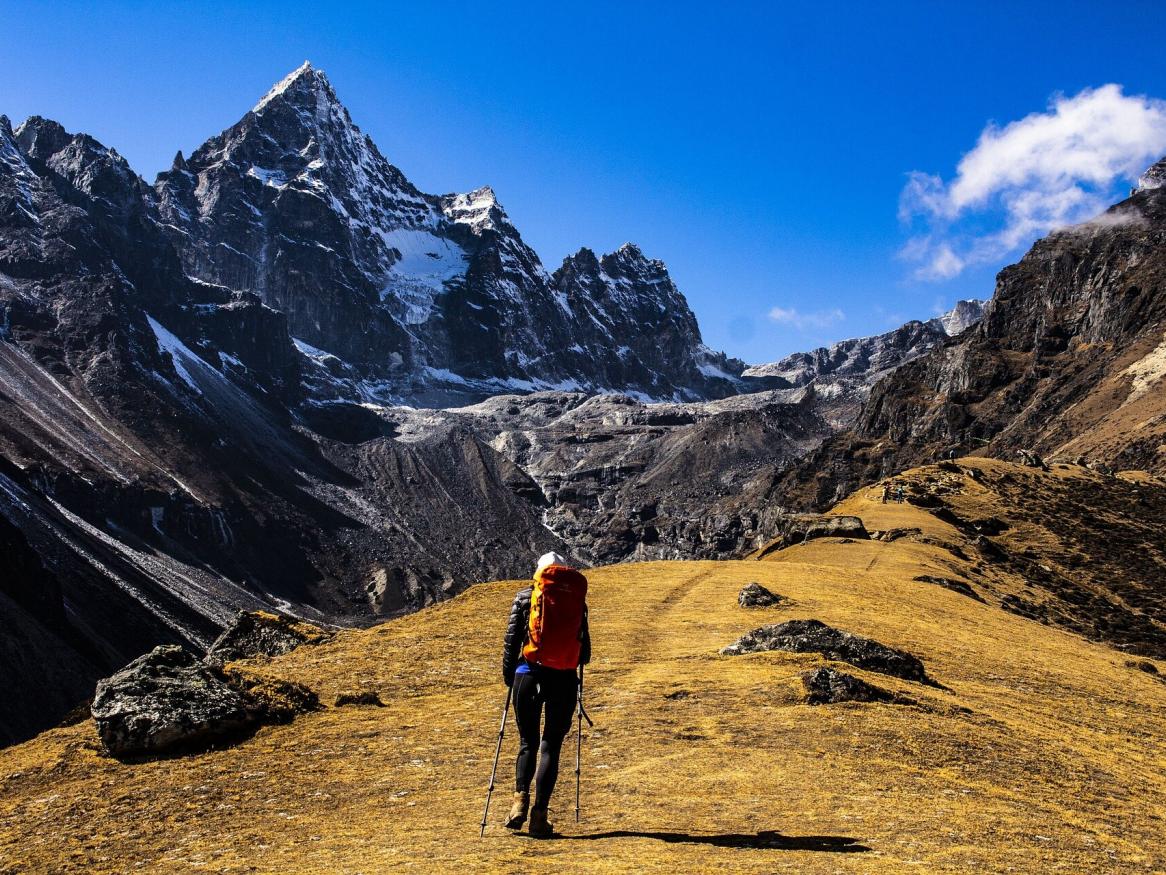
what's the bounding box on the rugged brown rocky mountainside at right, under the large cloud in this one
[770,177,1166,506]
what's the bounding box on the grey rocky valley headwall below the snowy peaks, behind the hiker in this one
[384,390,833,565]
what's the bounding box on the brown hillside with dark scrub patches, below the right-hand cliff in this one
[816,459,1166,659]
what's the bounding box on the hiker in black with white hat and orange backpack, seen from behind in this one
[503,553,591,838]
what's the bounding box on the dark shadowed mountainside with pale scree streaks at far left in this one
[0,102,567,740]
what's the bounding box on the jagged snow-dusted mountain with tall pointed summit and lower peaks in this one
[154,63,744,406]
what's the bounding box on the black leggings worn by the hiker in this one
[514,667,578,806]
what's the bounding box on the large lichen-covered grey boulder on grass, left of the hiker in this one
[91,644,255,756]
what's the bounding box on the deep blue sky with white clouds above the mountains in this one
[0,0,1166,362]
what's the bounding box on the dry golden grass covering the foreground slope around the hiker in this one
[0,461,1166,874]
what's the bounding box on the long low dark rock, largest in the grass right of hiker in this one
[721,620,930,683]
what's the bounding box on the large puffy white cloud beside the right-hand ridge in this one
[899,84,1166,280]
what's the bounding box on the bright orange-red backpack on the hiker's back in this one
[522,565,586,670]
